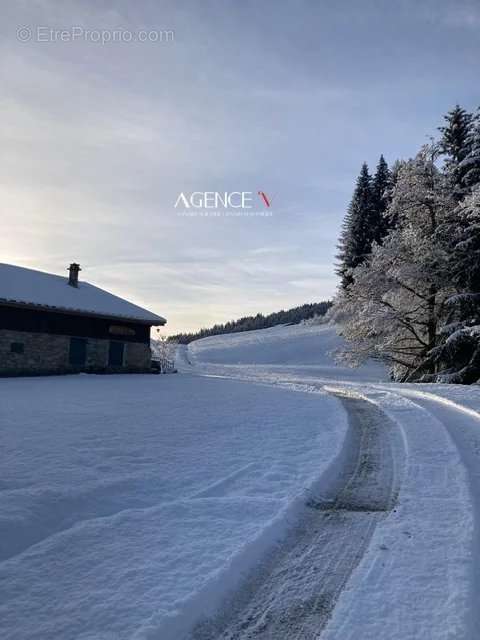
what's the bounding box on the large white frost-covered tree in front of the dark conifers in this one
[338,146,454,380]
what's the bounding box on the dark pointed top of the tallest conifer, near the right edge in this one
[439,104,472,200]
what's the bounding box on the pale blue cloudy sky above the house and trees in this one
[0,0,480,332]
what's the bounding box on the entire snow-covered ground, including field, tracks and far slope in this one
[0,325,480,640]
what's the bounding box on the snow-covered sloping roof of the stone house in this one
[0,263,166,325]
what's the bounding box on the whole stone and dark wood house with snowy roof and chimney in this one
[0,263,166,376]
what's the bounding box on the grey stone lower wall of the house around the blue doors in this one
[0,329,151,375]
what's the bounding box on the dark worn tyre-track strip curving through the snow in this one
[190,396,403,640]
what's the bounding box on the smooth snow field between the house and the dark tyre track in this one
[0,375,346,640]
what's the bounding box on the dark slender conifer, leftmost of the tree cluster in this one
[337,163,374,289]
